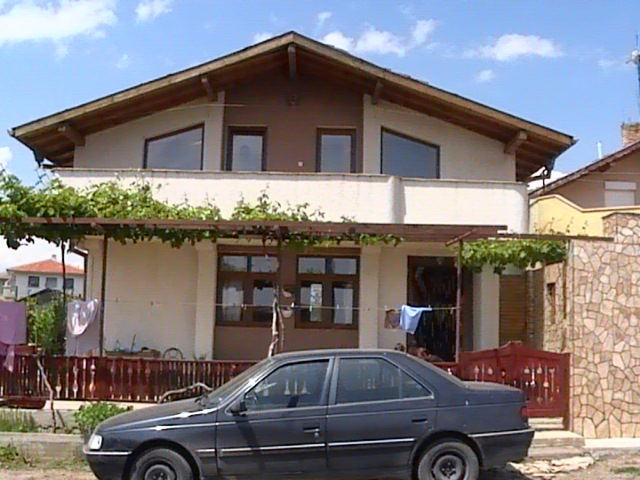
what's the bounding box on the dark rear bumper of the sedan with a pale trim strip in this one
[471,428,534,468]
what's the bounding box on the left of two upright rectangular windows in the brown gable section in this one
[225,127,267,172]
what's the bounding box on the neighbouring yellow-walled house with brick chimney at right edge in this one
[530,123,640,236]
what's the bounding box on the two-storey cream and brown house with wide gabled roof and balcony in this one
[11,32,574,360]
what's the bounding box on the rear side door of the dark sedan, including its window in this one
[327,357,436,478]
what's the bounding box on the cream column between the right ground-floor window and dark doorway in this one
[358,246,381,348]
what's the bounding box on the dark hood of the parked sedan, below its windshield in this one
[96,398,217,433]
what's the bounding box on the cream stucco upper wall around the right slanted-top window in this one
[363,95,516,181]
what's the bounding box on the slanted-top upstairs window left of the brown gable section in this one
[143,125,204,170]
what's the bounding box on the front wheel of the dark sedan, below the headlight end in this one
[130,448,193,480]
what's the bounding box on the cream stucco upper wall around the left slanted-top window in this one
[74,92,224,170]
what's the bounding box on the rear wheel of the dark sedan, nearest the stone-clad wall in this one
[418,440,480,480]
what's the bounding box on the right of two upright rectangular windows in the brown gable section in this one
[316,129,356,173]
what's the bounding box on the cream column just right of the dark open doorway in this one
[473,266,500,350]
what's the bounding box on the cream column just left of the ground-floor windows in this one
[193,242,217,359]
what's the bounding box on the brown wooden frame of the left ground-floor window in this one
[215,250,282,328]
